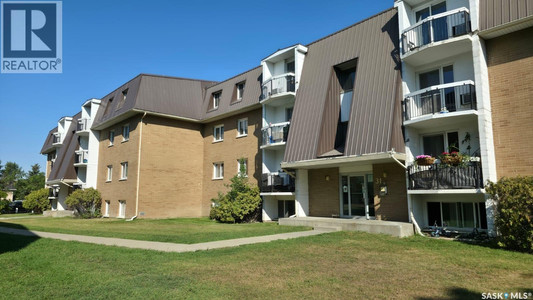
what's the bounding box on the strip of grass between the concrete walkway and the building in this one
[0,217,310,244]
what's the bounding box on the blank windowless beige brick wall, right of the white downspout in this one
[137,116,205,218]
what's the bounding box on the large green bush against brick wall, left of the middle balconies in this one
[209,173,261,223]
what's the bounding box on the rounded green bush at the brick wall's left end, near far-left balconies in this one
[65,188,102,218]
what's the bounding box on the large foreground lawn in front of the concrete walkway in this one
[0,232,533,299]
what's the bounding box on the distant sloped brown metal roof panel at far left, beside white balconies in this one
[48,112,81,181]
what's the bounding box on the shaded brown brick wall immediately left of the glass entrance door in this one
[308,168,340,217]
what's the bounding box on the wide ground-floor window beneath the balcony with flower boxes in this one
[427,202,487,229]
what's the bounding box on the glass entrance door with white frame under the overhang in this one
[341,174,374,218]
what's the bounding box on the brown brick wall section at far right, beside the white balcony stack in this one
[486,28,533,178]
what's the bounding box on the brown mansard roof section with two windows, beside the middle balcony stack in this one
[202,66,262,119]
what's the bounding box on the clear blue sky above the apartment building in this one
[0,0,393,171]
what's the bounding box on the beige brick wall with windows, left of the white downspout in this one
[96,115,141,218]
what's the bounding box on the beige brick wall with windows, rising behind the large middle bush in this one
[202,108,262,216]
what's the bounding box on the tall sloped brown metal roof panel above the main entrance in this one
[284,9,401,162]
